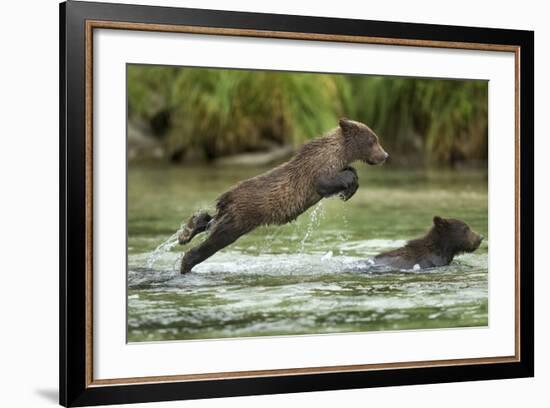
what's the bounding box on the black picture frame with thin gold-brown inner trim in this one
[60,1,534,406]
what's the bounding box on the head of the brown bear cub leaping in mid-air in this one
[340,118,389,164]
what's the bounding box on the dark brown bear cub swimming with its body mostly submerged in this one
[374,216,483,269]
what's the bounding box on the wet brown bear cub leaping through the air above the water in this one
[178,119,388,273]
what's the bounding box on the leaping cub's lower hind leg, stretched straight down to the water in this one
[180,220,248,274]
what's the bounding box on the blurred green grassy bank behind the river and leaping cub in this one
[127,65,488,165]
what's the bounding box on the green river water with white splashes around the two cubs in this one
[128,164,490,342]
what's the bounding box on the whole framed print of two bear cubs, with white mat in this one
[60,1,534,406]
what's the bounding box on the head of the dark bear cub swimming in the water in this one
[433,216,483,254]
